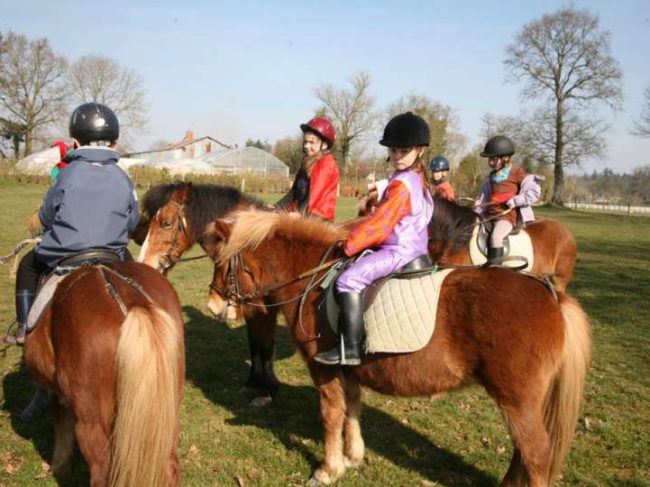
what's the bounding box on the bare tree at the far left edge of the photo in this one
[0,32,67,157]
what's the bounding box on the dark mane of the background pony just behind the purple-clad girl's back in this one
[429,198,477,258]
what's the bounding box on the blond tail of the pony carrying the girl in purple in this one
[544,293,591,485]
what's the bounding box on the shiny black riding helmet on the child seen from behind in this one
[70,102,120,144]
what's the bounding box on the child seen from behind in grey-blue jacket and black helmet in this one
[10,103,139,420]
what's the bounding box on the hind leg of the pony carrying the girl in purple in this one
[501,401,551,487]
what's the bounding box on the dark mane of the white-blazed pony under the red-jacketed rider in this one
[142,182,263,233]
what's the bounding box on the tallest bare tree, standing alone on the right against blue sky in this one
[504,7,622,205]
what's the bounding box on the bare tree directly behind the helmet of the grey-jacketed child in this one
[68,55,148,145]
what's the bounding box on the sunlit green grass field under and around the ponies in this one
[0,180,650,486]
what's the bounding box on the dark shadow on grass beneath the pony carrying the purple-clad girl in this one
[184,306,498,486]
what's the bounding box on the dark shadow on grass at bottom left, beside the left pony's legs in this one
[2,361,89,487]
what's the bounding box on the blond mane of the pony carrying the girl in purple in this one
[219,210,348,264]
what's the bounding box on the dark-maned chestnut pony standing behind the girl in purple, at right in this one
[359,194,577,291]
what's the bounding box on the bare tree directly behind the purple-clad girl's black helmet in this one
[386,93,465,164]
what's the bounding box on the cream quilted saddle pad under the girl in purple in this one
[328,269,453,353]
